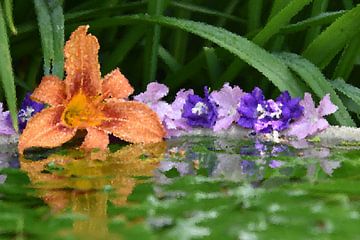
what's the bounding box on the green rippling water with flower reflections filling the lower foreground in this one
[0,137,360,240]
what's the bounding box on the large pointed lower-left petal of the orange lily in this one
[18,106,76,154]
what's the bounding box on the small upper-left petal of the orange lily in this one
[31,75,66,106]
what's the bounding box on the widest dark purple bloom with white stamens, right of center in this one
[237,88,303,133]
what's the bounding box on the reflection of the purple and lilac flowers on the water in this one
[157,138,340,183]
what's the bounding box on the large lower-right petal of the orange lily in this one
[99,101,165,143]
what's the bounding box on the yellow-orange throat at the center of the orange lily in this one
[61,92,104,128]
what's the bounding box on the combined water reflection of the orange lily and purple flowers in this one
[0,137,340,239]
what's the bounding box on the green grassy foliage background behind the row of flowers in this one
[0,0,360,126]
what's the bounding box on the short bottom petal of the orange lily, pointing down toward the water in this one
[81,128,109,150]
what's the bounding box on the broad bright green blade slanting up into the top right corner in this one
[303,5,360,69]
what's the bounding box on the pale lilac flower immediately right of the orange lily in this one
[134,82,171,121]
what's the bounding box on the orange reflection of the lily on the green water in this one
[20,143,166,239]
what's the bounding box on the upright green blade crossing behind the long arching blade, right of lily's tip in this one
[143,0,165,87]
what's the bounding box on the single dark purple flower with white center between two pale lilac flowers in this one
[182,87,218,128]
